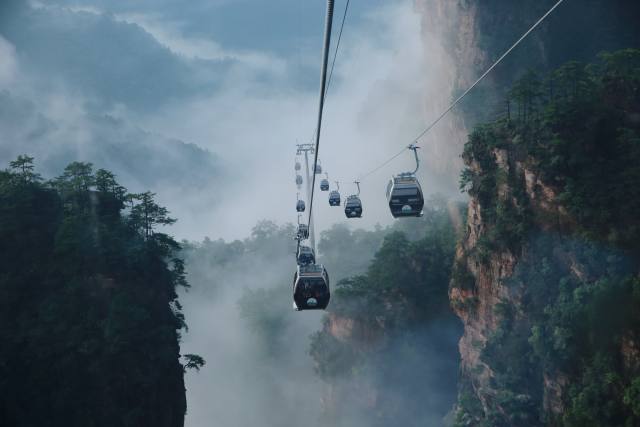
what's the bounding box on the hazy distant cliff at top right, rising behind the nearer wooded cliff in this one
[415,0,640,125]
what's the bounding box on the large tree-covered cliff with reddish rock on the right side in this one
[452,49,640,427]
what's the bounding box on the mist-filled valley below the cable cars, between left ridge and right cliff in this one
[180,204,461,427]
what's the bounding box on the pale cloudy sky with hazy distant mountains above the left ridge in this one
[0,0,462,239]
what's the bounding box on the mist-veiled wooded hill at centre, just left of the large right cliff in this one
[310,199,461,426]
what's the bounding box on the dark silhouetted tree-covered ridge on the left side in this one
[0,155,203,427]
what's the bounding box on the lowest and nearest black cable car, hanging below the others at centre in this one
[293,264,331,311]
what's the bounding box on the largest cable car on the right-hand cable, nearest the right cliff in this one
[387,173,424,218]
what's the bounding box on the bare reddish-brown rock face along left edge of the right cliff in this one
[449,149,562,425]
